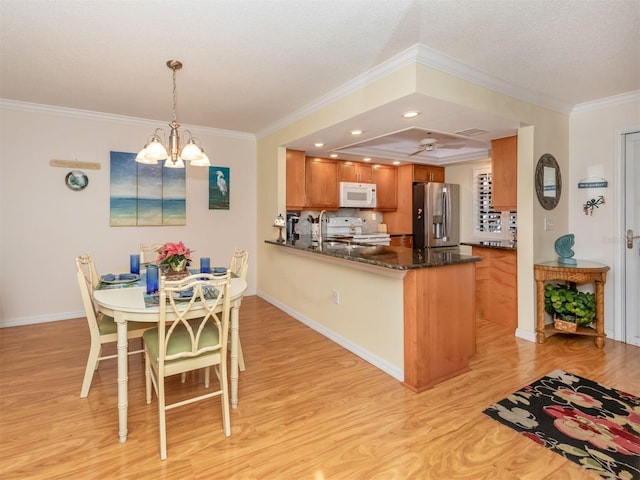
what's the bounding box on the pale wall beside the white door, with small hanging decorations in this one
[563,92,640,340]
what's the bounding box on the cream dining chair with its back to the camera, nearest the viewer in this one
[144,272,231,460]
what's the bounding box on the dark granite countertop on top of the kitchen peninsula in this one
[265,236,481,270]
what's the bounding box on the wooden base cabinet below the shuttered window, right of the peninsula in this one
[472,246,518,330]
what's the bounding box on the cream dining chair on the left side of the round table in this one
[76,253,151,398]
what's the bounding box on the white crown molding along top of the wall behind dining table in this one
[0,98,256,140]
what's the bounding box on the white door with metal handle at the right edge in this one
[623,132,640,346]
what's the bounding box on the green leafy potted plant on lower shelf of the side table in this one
[544,283,596,332]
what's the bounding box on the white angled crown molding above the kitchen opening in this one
[257,43,572,138]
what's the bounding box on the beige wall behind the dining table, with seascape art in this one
[0,102,257,326]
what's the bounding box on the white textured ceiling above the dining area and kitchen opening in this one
[0,0,640,163]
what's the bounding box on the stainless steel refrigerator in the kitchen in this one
[413,182,460,248]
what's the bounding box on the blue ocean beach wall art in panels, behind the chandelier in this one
[109,152,186,227]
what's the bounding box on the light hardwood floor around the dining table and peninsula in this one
[0,297,640,480]
